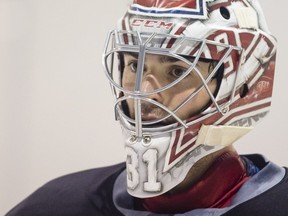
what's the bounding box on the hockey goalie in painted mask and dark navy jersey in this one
[8,0,288,216]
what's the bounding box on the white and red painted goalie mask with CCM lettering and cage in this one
[103,0,276,198]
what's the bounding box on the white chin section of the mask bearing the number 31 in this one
[125,129,223,198]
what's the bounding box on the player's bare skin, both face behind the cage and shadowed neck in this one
[122,53,235,194]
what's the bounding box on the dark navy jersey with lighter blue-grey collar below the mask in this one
[7,155,288,216]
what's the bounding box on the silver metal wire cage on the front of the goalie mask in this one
[102,30,244,137]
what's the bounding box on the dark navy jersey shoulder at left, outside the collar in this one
[7,163,125,216]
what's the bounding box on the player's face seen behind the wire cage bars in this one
[122,53,217,124]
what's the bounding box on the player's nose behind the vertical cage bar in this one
[141,73,162,102]
